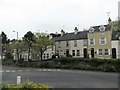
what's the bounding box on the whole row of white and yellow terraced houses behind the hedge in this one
[14,19,120,60]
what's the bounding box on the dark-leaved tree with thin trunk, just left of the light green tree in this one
[23,31,34,60]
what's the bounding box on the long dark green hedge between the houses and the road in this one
[3,57,120,72]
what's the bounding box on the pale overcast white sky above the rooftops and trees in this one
[0,0,120,39]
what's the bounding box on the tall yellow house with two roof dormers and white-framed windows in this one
[88,24,112,58]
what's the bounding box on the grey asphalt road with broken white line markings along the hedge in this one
[2,66,118,88]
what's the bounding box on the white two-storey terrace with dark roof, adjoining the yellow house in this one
[55,27,87,57]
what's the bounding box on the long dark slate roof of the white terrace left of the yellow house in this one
[53,31,88,41]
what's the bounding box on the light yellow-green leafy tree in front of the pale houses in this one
[32,33,52,60]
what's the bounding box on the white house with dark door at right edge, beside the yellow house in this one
[111,32,120,59]
